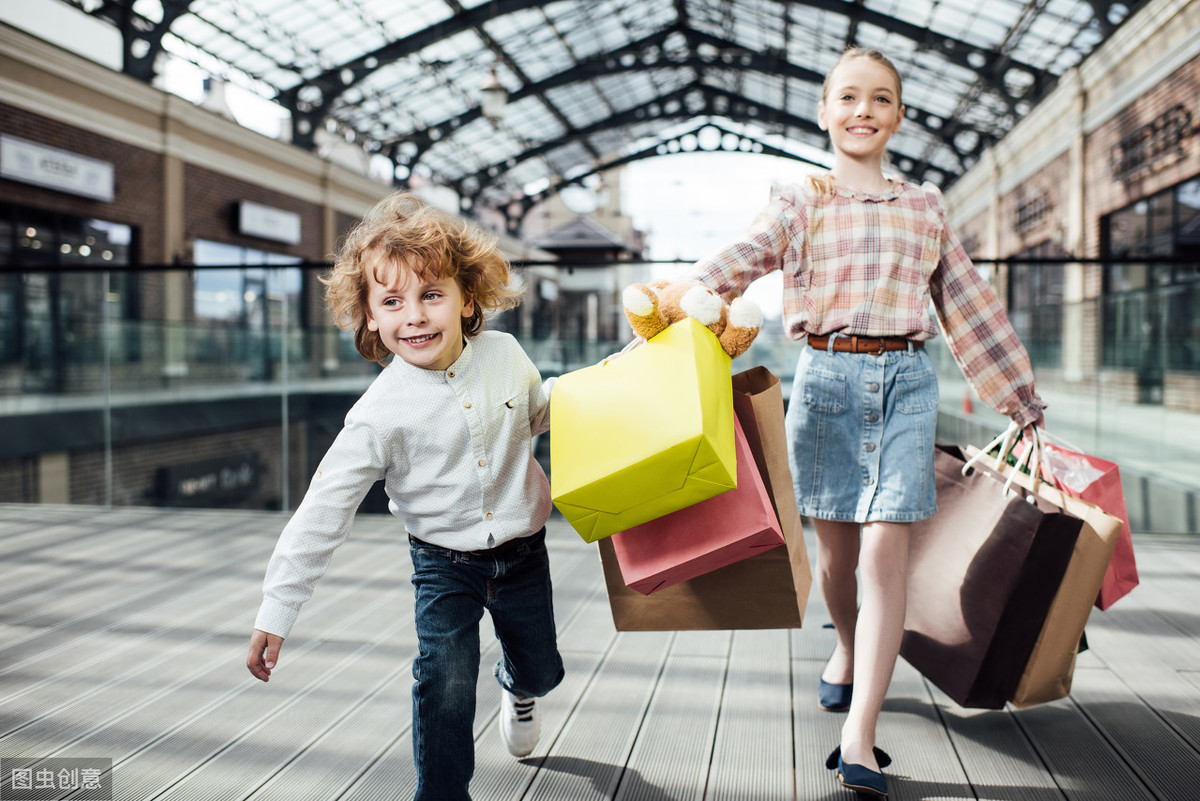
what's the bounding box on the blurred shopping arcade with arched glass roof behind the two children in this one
[0,0,1200,532]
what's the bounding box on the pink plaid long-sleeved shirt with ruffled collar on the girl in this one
[692,178,1045,426]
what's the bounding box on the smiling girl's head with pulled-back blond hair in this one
[817,58,904,161]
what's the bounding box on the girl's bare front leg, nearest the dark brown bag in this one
[844,523,908,771]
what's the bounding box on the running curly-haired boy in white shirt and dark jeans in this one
[246,193,563,801]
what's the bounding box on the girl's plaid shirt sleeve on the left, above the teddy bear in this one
[688,183,805,300]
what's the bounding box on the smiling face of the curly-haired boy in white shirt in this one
[367,253,475,371]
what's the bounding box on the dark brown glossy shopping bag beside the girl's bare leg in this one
[900,447,1082,709]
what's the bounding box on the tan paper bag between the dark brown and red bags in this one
[967,446,1124,707]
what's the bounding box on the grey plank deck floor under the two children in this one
[0,505,1200,801]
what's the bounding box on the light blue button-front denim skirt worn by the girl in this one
[786,337,937,523]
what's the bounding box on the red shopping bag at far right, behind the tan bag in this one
[1042,444,1138,609]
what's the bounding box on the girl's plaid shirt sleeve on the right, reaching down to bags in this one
[926,185,1046,426]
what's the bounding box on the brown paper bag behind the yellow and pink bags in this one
[596,367,812,631]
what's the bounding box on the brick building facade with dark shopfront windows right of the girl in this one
[947,0,1200,411]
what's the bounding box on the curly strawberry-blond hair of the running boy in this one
[320,192,521,362]
